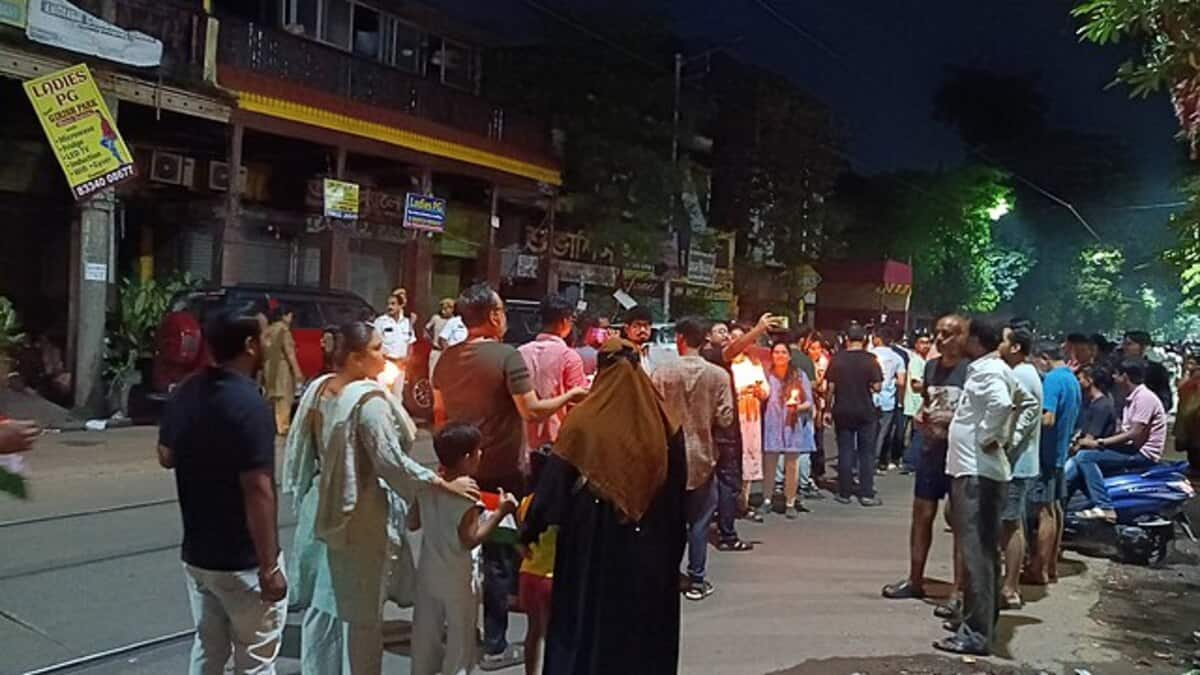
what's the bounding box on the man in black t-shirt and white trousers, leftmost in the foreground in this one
[158,307,288,674]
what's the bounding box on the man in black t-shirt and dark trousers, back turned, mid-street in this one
[826,323,883,507]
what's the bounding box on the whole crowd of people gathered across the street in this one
[150,279,1200,675]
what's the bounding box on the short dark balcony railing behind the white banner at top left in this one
[74,0,208,82]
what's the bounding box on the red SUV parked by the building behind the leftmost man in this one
[142,285,433,417]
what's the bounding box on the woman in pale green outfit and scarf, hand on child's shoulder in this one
[284,322,479,675]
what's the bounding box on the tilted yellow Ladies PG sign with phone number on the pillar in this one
[25,64,137,199]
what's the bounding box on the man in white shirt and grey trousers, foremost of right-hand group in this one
[934,318,1020,656]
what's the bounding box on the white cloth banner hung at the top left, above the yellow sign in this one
[25,0,162,68]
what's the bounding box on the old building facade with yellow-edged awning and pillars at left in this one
[0,0,560,407]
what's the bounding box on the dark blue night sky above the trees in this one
[439,0,1183,201]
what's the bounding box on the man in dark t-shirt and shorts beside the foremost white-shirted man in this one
[883,315,968,599]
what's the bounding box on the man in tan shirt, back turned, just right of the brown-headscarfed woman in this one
[650,317,734,601]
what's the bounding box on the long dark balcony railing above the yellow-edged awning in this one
[217,17,551,157]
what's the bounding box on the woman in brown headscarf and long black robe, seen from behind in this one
[522,339,688,675]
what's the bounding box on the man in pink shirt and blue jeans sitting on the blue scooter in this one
[1073,359,1166,522]
